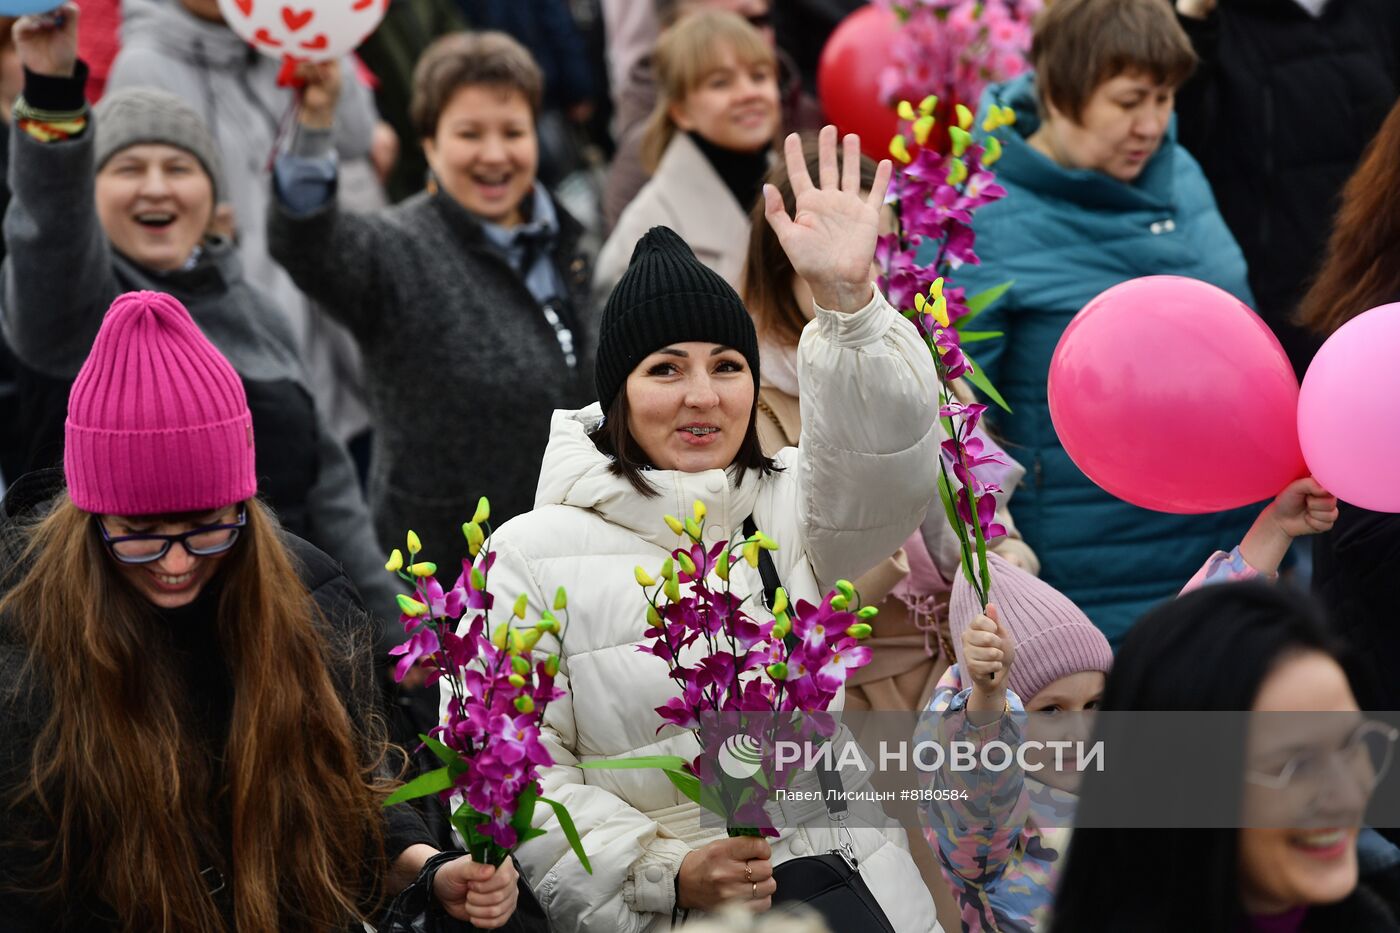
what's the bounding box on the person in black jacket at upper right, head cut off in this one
[1176,0,1400,378]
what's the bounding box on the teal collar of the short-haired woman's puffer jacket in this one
[979,71,1176,212]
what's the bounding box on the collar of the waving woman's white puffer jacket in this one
[535,402,762,551]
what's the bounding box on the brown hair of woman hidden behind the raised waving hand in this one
[743,133,875,346]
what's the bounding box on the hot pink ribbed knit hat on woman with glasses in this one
[63,291,258,516]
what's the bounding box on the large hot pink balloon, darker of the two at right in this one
[1049,276,1306,514]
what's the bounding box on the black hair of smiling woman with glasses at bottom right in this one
[1051,583,1350,933]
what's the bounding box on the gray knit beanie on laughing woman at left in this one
[92,87,227,205]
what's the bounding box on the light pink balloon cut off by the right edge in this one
[1298,304,1400,513]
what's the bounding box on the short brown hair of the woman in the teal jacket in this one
[1030,0,1196,123]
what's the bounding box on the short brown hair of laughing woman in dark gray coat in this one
[409,32,545,139]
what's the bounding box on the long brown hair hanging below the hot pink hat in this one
[0,493,385,933]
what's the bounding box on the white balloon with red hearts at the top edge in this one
[218,0,389,63]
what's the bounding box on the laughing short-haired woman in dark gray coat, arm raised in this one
[269,32,591,548]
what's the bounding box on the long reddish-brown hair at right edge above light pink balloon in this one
[1296,102,1400,335]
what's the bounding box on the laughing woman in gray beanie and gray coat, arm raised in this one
[0,4,395,616]
